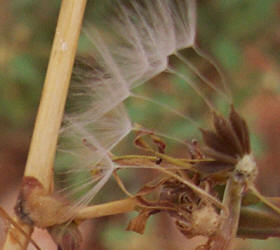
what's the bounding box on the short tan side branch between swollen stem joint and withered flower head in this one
[75,198,138,220]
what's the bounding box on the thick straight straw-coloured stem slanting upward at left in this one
[3,0,87,250]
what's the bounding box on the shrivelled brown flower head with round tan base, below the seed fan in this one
[160,176,221,238]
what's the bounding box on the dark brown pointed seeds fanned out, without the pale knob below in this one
[195,106,251,177]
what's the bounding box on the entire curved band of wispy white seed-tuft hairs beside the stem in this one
[55,0,208,211]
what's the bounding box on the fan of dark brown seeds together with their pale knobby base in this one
[195,104,257,185]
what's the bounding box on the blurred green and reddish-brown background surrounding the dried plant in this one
[0,0,280,250]
